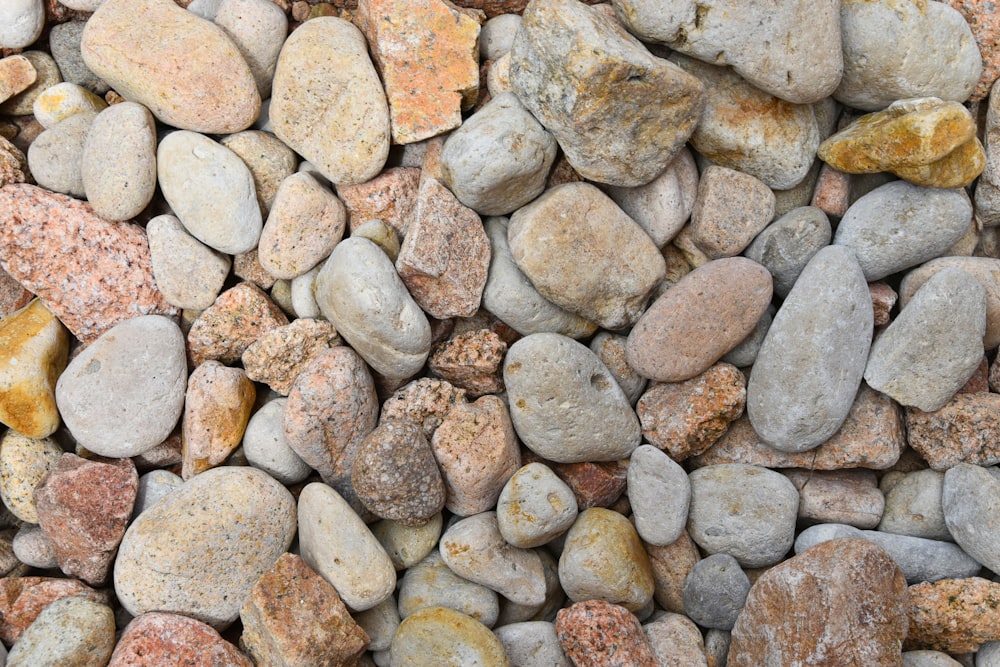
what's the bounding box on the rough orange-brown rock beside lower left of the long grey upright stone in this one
[635,364,747,462]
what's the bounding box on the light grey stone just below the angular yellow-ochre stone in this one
[833,181,972,281]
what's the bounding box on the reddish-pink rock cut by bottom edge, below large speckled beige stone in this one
[108,611,253,667]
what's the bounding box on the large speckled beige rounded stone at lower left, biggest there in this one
[114,467,296,629]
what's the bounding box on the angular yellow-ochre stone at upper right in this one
[817,97,976,174]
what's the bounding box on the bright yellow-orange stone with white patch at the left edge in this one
[0,299,69,438]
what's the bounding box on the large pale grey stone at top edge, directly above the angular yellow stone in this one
[833,0,982,111]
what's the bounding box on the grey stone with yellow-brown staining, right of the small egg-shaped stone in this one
[559,507,654,612]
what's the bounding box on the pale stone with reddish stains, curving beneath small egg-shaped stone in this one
[439,512,546,605]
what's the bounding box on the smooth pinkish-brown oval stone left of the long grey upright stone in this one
[625,257,771,382]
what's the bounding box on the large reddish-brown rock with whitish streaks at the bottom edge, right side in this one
[727,538,908,667]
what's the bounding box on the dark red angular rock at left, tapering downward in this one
[34,453,139,586]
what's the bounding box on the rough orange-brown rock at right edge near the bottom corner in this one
[903,577,1000,653]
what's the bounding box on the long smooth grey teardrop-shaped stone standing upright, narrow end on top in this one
[747,246,874,453]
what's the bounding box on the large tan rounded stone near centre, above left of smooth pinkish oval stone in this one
[507,183,665,329]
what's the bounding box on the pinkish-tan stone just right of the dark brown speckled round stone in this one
[431,396,521,516]
